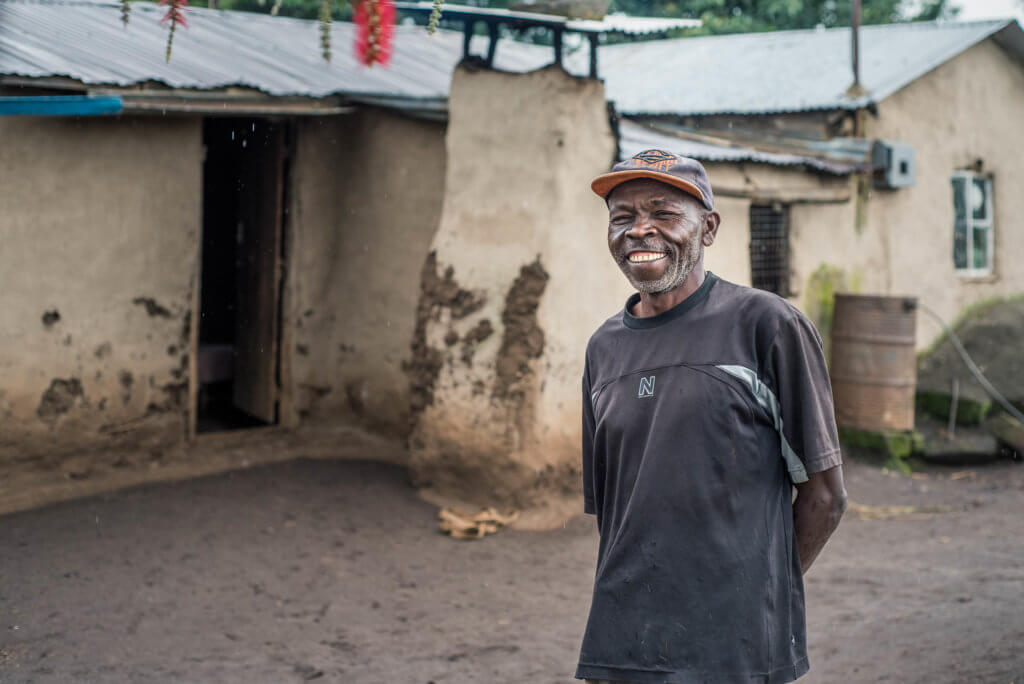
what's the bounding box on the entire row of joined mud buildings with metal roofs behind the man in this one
[0,0,1024,525]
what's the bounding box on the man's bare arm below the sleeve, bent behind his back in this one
[793,466,846,574]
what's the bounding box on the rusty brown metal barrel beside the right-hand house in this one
[829,295,918,431]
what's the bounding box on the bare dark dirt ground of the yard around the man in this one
[0,450,1024,684]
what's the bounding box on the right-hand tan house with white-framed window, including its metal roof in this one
[602,20,1024,347]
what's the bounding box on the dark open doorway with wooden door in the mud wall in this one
[196,118,287,433]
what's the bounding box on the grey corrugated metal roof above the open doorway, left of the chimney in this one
[0,0,552,100]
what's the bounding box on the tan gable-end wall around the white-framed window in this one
[868,40,1024,344]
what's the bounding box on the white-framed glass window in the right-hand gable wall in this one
[952,171,992,275]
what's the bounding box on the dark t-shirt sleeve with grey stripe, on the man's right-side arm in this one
[766,311,843,482]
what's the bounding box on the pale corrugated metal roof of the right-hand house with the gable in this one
[574,19,1024,115]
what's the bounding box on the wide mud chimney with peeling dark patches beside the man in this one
[409,67,629,524]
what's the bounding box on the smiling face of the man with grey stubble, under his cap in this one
[608,178,718,294]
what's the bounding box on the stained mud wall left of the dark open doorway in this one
[0,117,203,476]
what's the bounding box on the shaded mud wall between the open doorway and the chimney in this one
[284,110,445,436]
